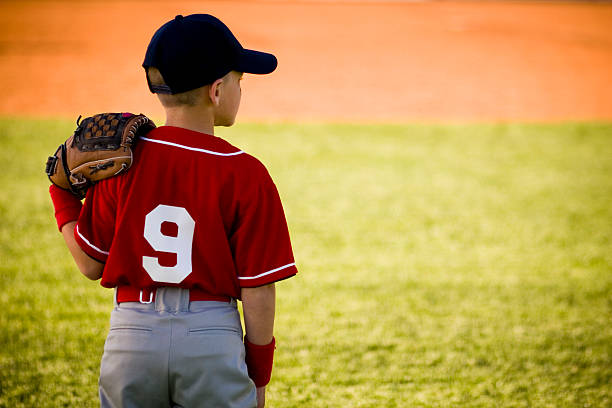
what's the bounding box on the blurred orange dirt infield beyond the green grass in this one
[0,0,612,122]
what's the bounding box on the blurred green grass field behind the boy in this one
[0,118,612,407]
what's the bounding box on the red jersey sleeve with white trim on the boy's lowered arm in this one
[230,165,297,287]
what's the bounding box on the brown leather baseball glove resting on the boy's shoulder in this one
[45,113,155,198]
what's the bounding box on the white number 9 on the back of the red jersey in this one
[142,204,195,283]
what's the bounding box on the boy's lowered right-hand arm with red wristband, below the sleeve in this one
[241,283,276,408]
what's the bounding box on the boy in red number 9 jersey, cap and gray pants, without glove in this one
[50,14,297,407]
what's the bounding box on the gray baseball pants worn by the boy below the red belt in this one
[99,288,257,408]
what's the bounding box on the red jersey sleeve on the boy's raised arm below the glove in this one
[74,179,116,263]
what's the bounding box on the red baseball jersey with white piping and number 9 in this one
[75,126,297,298]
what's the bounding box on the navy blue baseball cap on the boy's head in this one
[142,14,277,94]
